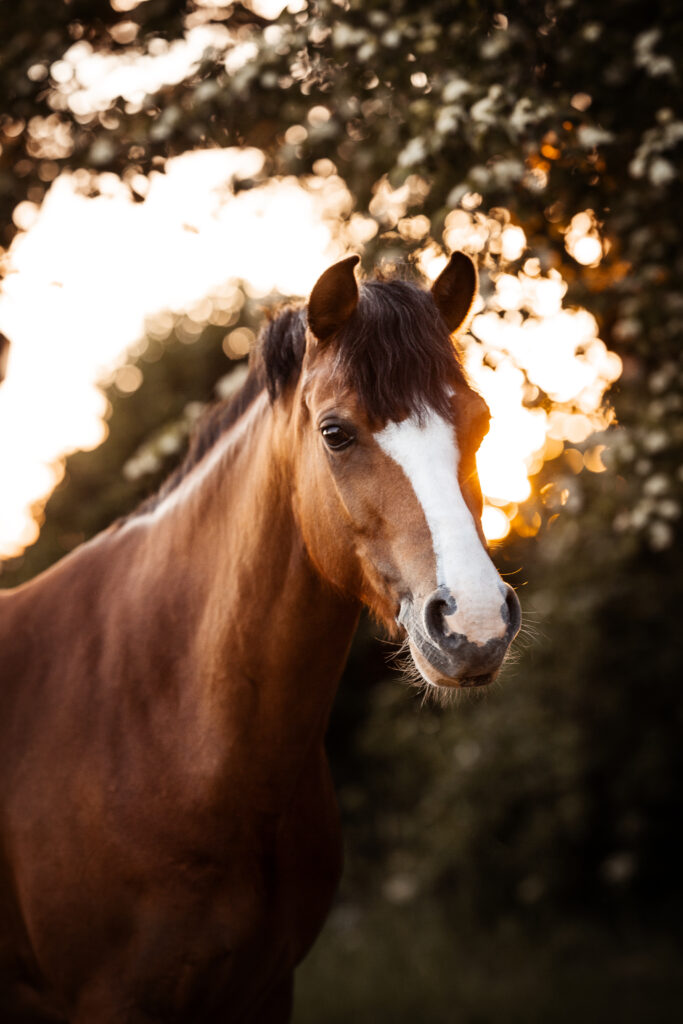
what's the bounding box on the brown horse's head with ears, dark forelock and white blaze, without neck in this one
[266,253,521,687]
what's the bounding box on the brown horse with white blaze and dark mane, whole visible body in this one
[0,253,520,1024]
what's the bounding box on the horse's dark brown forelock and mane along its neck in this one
[123,280,465,521]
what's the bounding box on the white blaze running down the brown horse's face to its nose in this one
[375,412,507,643]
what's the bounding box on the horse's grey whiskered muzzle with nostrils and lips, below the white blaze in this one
[398,583,521,687]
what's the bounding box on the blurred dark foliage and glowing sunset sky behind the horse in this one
[0,0,683,1024]
